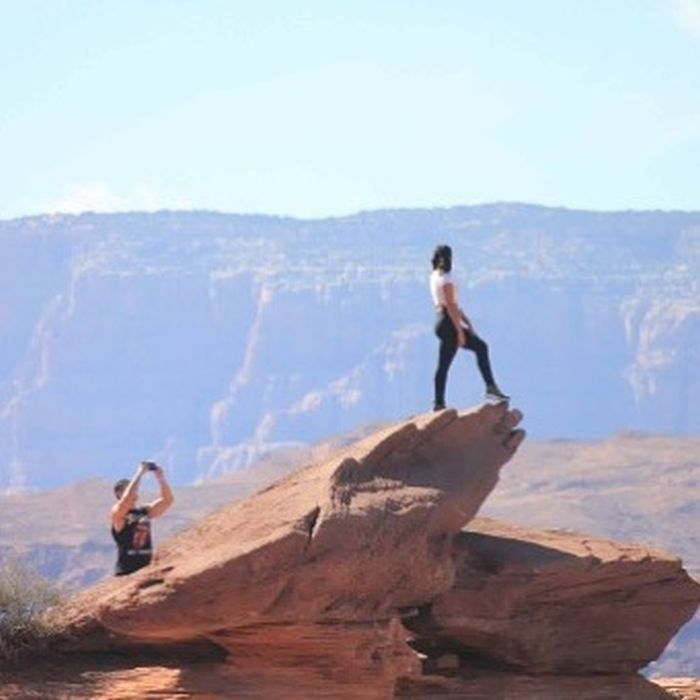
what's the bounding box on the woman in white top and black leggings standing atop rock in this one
[430,245,510,411]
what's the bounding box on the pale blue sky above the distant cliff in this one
[0,0,700,218]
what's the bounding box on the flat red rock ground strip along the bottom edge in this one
[0,658,688,700]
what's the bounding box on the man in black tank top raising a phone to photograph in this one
[112,462,174,576]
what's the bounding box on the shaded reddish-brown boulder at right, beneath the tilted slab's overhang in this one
[406,518,700,674]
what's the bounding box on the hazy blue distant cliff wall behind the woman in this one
[0,204,700,488]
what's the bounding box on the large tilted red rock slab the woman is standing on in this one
[56,404,524,646]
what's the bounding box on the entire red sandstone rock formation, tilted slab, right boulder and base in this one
[3,404,700,700]
